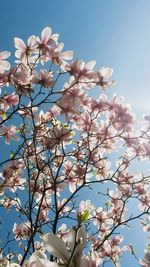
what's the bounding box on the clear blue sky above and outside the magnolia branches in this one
[0,0,150,267]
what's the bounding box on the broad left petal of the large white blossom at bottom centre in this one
[43,234,70,262]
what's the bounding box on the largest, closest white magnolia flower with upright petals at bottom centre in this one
[43,226,87,267]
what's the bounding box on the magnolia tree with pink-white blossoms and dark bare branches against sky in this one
[0,27,150,267]
